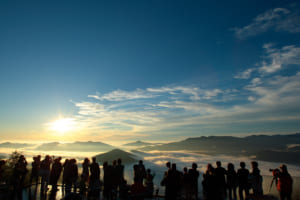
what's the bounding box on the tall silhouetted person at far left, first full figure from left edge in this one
[12,155,28,199]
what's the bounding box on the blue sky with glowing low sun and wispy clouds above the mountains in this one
[0,0,300,143]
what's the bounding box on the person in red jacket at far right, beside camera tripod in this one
[277,165,293,200]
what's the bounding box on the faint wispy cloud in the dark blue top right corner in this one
[232,7,300,39]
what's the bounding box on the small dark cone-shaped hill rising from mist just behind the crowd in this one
[96,149,137,164]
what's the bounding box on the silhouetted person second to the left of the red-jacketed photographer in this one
[237,162,249,200]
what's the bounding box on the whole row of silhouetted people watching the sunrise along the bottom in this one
[0,155,293,200]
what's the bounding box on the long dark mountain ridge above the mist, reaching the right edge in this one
[139,133,300,164]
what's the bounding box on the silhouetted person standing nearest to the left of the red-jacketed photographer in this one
[249,161,263,197]
